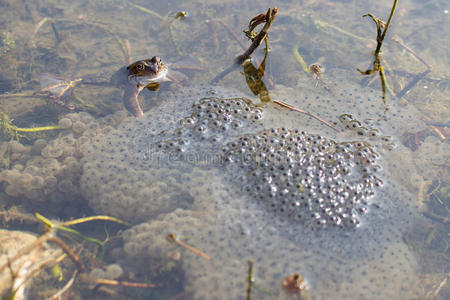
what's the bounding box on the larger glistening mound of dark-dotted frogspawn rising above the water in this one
[222,128,382,228]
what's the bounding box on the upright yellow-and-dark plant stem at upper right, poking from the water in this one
[357,0,398,106]
